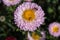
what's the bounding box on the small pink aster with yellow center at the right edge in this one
[48,22,60,37]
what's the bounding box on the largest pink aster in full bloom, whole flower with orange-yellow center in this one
[14,2,45,31]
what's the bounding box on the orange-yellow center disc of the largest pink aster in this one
[22,9,35,21]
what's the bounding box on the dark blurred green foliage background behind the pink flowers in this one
[0,0,60,40]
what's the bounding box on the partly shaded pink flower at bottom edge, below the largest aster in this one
[27,32,45,40]
